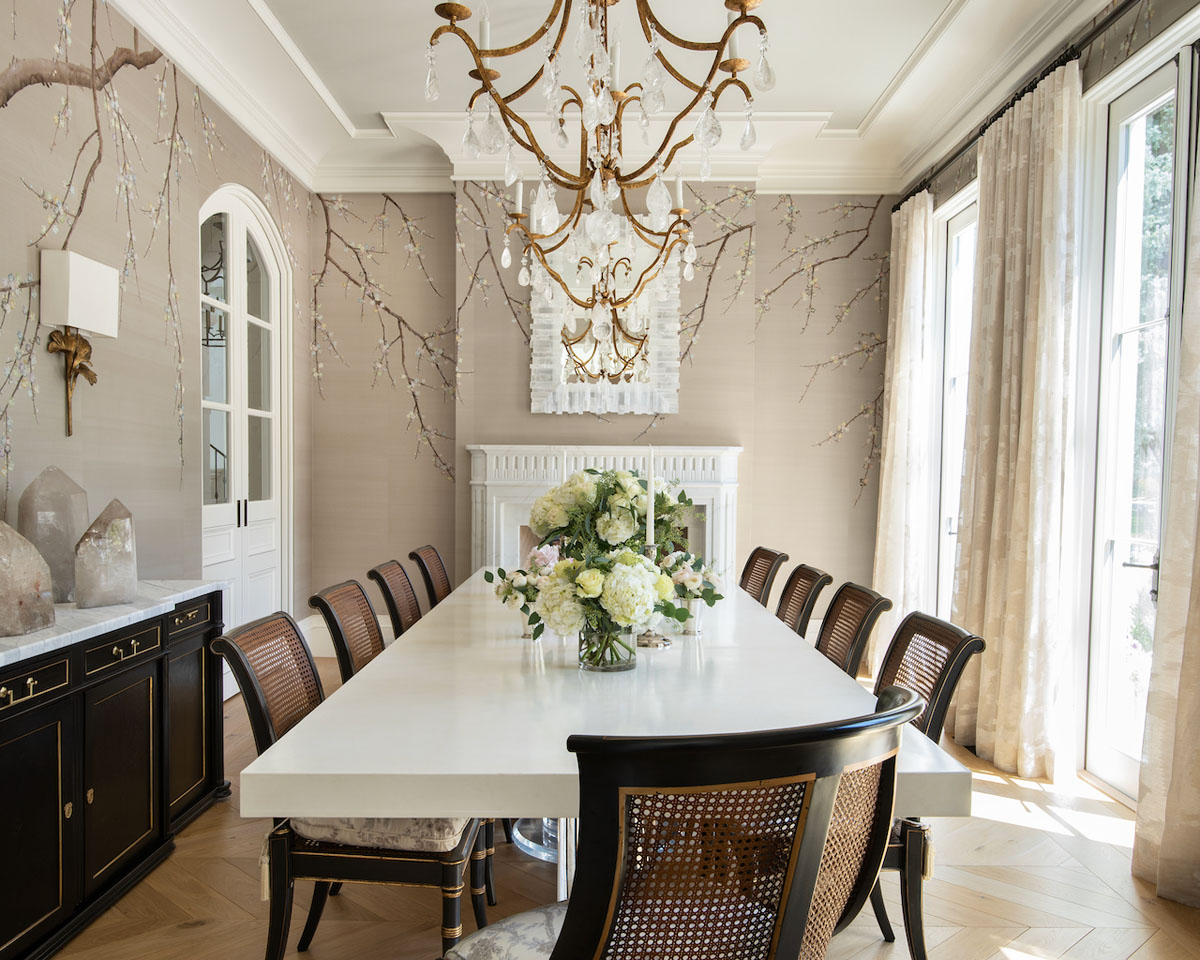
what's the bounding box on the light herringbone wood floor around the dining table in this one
[61,660,1200,960]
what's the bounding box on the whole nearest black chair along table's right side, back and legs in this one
[871,613,984,960]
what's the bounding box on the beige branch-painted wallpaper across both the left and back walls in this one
[0,0,890,616]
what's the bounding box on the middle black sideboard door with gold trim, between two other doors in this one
[82,661,163,896]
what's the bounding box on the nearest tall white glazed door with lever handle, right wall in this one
[1086,62,1186,797]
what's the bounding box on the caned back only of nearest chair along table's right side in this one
[875,613,984,743]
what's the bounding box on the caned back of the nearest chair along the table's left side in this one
[212,611,325,754]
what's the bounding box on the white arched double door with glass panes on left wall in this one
[200,202,284,626]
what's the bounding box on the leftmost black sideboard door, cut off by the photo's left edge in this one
[0,698,83,956]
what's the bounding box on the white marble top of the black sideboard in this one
[0,580,228,668]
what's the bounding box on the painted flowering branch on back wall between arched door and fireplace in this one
[311,194,457,480]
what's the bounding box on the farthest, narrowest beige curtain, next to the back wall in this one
[866,191,941,676]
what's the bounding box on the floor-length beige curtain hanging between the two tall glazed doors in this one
[948,62,1081,776]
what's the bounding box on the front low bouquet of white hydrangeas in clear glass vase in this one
[529,547,688,671]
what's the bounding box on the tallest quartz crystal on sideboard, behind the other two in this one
[17,467,91,604]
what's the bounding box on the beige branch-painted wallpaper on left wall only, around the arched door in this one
[0,0,313,605]
